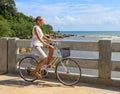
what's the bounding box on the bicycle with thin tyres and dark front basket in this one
[18,42,81,86]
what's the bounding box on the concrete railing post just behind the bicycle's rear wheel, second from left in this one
[8,38,18,73]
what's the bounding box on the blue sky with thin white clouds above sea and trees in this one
[14,0,120,31]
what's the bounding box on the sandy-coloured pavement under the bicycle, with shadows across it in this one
[0,74,120,94]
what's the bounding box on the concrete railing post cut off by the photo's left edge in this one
[0,38,7,74]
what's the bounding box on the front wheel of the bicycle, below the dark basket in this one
[55,58,81,86]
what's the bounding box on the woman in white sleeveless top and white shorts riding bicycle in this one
[31,16,54,78]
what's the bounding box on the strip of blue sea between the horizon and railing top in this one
[59,31,120,41]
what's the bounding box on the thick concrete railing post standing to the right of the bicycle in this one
[98,40,111,85]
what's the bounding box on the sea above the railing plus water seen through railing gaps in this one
[54,31,120,80]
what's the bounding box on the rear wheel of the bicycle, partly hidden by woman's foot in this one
[19,56,38,82]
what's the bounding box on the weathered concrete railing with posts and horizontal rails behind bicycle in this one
[0,38,120,86]
